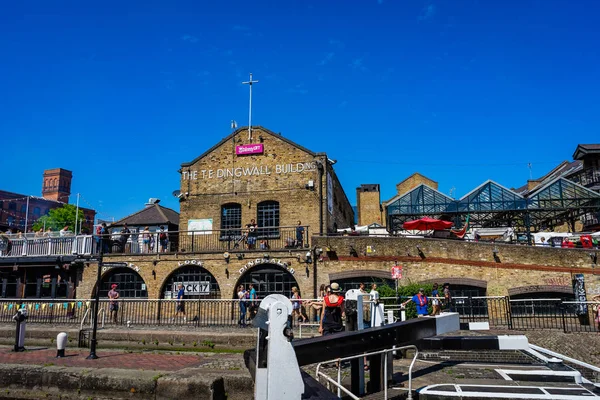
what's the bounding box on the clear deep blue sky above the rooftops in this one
[0,0,600,219]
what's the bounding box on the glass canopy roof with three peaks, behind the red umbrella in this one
[386,178,600,232]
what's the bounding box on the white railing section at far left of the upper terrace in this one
[0,235,94,257]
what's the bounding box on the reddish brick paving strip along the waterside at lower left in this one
[0,347,243,371]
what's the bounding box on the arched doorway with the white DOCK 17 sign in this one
[160,264,221,299]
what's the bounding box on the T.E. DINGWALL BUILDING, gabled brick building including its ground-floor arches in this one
[78,127,354,298]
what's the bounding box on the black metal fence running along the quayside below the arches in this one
[0,297,600,332]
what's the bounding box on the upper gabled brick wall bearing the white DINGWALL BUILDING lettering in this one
[179,128,352,232]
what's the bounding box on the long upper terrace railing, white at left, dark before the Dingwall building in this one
[0,226,309,257]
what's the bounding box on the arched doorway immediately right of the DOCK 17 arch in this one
[232,264,300,299]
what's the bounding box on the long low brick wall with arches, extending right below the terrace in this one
[77,236,600,298]
